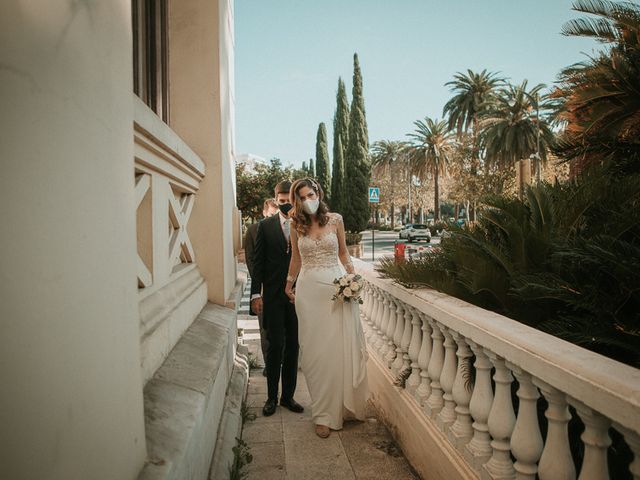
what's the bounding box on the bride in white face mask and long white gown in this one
[285,178,368,438]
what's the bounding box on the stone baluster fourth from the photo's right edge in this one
[507,363,544,480]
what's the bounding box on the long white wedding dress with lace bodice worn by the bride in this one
[296,214,368,430]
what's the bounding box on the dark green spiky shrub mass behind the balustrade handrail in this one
[379,176,640,367]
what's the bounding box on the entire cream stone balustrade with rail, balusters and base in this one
[356,261,640,480]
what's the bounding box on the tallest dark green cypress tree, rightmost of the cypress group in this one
[343,53,371,233]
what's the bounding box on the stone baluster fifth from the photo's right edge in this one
[482,350,516,480]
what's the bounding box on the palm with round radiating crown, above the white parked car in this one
[406,117,454,220]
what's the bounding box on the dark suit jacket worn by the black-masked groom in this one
[251,213,291,312]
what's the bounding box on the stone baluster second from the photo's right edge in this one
[569,399,611,480]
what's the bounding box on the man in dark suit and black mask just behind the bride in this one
[251,180,304,417]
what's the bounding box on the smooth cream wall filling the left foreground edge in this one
[0,0,146,480]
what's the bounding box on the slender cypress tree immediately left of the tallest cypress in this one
[331,78,349,212]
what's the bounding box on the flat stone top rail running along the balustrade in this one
[354,260,640,433]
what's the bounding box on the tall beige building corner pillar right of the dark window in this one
[169,0,236,305]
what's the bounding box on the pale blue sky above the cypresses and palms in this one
[235,0,601,166]
